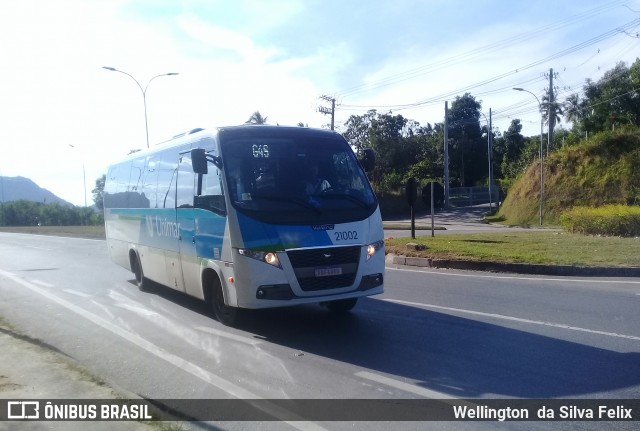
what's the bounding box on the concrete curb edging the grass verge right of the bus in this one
[386,254,640,277]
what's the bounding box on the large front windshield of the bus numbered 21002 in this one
[220,135,377,224]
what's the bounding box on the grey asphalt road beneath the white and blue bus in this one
[0,234,640,430]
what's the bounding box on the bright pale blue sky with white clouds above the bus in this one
[0,0,640,206]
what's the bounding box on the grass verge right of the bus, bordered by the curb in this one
[385,231,640,267]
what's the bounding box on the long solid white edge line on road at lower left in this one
[0,269,326,431]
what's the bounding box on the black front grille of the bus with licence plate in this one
[287,246,360,291]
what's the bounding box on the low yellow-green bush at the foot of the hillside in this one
[560,205,640,237]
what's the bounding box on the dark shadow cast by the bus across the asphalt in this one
[236,298,640,398]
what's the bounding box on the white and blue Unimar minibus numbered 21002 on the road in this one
[104,125,384,325]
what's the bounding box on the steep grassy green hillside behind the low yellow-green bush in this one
[497,128,640,225]
